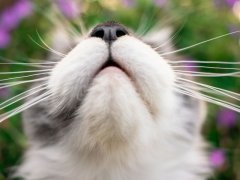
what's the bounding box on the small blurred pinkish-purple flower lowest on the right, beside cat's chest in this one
[210,149,226,168]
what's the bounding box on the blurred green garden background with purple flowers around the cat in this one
[0,0,240,180]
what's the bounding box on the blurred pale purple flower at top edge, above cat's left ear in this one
[57,0,79,19]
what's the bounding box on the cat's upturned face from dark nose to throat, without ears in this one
[25,23,205,155]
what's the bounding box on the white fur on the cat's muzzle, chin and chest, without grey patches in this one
[19,36,209,180]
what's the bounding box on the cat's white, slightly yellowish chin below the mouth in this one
[62,63,153,155]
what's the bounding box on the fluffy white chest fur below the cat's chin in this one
[22,140,208,180]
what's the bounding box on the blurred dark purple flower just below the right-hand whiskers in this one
[218,108,237,127]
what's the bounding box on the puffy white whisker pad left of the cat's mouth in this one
[48,38,108,114]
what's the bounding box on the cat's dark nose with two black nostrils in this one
[90,22,129,43]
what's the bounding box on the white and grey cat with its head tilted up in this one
[15,21,212,180]
